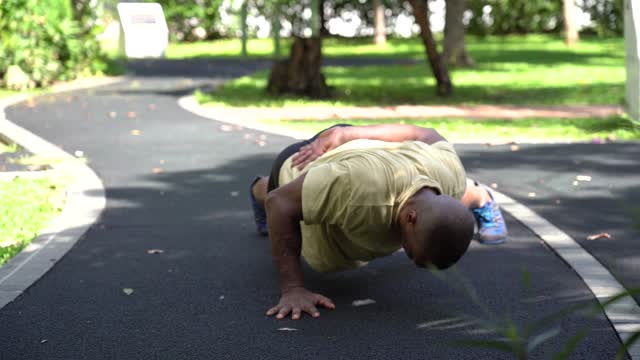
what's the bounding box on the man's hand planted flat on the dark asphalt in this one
[267,287,336,320]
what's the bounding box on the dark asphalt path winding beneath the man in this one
[0,61,637,359]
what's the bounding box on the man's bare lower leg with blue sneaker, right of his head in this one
[461,179,508,245]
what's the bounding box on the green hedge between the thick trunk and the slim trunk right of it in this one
[467,0,562,35]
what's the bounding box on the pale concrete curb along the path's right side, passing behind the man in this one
[178,96,640,360]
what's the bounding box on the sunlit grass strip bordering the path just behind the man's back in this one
[265,117,640,142]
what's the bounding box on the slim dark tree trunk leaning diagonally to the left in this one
[409,0,453,96]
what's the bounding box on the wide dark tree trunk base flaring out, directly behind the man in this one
[267,36,331,99]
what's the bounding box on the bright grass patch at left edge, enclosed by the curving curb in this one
[0,178,64,265]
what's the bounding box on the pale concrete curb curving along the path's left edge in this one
[0,77,125,309]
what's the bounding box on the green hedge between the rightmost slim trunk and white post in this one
[582,0,624,36]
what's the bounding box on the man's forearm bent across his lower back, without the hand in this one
[340,124,445,144]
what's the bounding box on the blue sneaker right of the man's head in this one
[471,188,508,245]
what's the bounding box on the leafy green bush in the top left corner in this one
[0,0,104,86]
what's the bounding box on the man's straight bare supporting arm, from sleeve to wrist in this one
[265,175,304,292]
